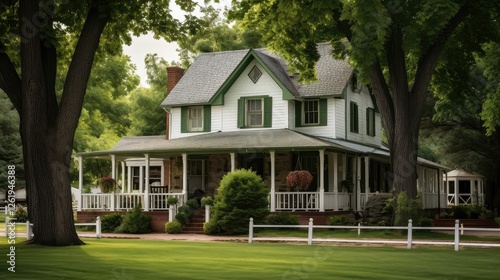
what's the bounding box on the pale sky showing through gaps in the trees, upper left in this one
[123,0,231,87]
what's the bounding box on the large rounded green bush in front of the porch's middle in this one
[212,169,269,234]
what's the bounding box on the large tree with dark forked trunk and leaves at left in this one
[0,0,200,245]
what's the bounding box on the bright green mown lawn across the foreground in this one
[0,238,500,280]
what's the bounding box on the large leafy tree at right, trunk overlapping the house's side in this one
[230,0,500,198]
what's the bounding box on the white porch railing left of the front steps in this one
[81,193,183,210]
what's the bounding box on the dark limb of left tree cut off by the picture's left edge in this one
[0,42,22,115]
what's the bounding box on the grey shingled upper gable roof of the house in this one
[161,43,353,107]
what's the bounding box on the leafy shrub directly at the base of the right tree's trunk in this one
[394,192,422,226]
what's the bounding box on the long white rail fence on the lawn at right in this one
[248,218,500,251]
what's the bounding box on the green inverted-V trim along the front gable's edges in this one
[208,49,296,105]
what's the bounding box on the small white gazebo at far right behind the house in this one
[447,169,484,206]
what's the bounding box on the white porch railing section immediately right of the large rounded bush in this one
[276,192,319,210]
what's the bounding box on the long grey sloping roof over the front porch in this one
[77,129,357,158]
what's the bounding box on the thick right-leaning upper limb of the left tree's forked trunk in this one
[56,5,108,143]
